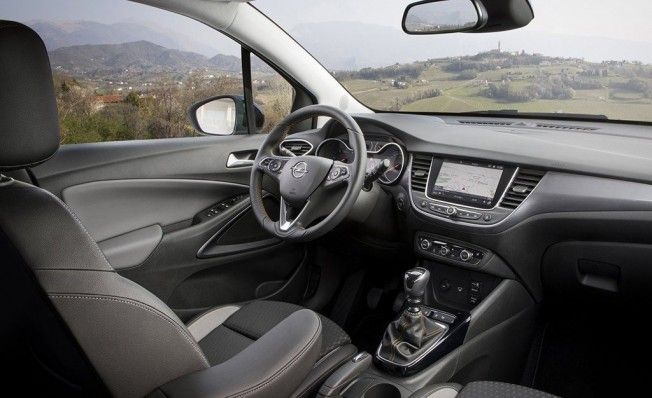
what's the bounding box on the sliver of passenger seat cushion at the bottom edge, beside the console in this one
[410,381,557,398]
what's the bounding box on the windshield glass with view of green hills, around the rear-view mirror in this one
[254,0,652,122]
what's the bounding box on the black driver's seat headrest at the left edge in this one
[0,20,59,170]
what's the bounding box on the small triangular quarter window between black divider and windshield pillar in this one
[251,54,295,133]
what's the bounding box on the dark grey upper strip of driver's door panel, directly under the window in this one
[32,134,265,196]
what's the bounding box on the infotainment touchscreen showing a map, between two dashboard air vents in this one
[429,160,505,207]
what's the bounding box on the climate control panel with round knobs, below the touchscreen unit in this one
[415,232,488,265]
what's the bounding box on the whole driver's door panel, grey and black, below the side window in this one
[32,135,308,319]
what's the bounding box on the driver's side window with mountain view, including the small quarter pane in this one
[0,0,294,144]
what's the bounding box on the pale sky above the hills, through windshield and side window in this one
[0,0,652,62]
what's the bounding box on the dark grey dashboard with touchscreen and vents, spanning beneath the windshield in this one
[288,113,652,299]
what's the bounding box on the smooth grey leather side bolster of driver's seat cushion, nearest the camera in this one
[153,309,321,398]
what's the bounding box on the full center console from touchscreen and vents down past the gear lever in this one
[321,153,545,398]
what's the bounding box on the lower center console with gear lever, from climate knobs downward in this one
[319,243,536,398]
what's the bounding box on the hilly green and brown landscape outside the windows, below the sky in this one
[50,41,652,143]
